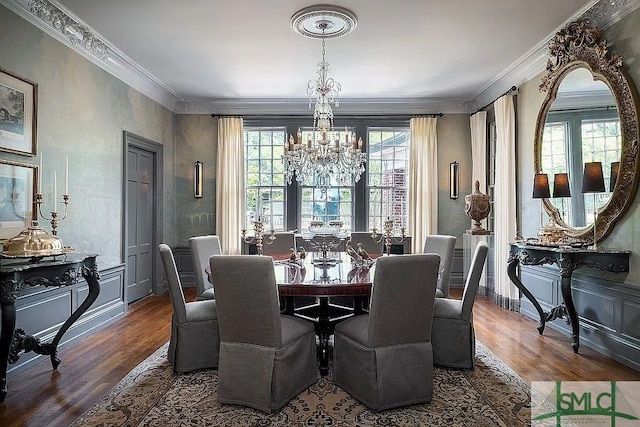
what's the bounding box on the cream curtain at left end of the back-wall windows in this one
[216,117,245,255]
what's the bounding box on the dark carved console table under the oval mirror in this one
[507,243,631,353]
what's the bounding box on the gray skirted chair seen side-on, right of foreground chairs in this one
[431,242,488,368]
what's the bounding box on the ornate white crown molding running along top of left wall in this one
[0,0,178,111]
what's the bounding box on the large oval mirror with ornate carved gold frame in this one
[534,22,640,243]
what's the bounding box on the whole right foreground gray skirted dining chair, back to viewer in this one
[334,254,440,411]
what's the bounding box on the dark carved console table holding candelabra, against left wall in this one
[0,253,100,402]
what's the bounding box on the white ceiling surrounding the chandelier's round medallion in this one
[15,0,616,114]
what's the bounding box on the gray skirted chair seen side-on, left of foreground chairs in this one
[160,243,220,373]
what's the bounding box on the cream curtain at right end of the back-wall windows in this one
[408,117,438,253]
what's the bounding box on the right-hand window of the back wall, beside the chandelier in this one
[367,128,409,230]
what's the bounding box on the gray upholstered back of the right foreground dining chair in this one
[368,254,440,347]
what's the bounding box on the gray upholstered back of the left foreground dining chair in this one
[209,255,282,348]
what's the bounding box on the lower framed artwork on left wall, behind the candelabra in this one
[0,160,38,240]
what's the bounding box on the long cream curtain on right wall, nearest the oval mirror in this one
[493,95,520,311]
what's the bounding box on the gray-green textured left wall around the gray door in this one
[0,6,176,268]
